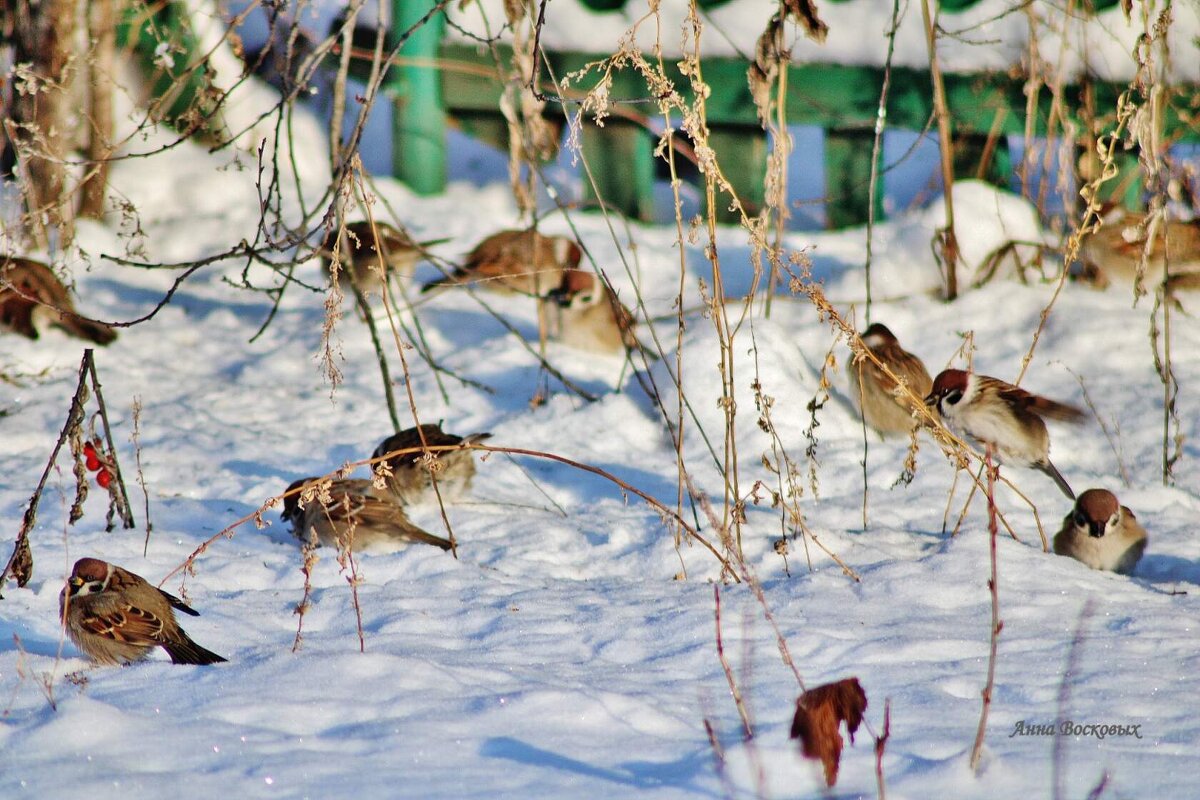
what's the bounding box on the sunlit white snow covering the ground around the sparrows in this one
[0,34,1200,799]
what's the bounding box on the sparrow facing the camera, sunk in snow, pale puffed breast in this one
[1054,489,1148,575]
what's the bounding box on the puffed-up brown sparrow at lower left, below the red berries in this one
[59,559,224,664]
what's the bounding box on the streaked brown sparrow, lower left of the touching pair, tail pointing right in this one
[281,477,450,553]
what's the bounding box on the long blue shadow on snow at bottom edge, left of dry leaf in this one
[480,736,719,798]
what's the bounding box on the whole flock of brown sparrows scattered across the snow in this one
[0,209,1180,664]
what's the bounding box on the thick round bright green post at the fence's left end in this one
[386,0,446,194]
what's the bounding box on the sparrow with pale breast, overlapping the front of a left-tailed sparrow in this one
[546,269,637,353]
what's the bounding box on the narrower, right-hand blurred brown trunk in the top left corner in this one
[79,0,119,219]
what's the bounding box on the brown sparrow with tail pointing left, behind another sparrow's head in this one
[421,229,583,297]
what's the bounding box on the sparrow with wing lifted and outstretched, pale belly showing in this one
[925,369,1084,500]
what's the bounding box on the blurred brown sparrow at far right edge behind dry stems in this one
[1079,209,1200,291]
